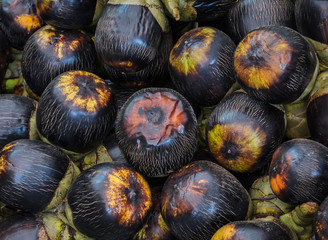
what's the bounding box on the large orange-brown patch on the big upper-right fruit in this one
[234,30,295,90]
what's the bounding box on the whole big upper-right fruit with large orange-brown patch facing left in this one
[234,26,319,104]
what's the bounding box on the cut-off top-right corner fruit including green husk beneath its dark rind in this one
[295,0,328,70]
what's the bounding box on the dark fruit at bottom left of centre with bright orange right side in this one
[67,162,151,240]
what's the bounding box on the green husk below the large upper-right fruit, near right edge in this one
[284,99,310,139]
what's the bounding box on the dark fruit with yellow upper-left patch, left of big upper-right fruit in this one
[169,27,236,106]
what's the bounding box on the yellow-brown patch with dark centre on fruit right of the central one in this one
[207,123,267,172]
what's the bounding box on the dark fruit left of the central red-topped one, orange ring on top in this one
[36,70,116,153]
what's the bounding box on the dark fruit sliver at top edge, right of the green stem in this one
[192,0,238,22]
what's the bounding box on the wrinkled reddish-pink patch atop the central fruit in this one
[123,92,188,145]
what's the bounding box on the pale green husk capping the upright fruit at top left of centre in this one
[107,0,170,32]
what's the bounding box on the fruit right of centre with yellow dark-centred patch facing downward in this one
[206,92,286,172]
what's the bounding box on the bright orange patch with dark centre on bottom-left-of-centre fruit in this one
[105,168,152,227]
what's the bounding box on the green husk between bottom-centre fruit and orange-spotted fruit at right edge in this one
[249,175,294,219]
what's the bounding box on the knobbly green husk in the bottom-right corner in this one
[280,202,319,240]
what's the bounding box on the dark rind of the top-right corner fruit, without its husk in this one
[295,0,328,44]
